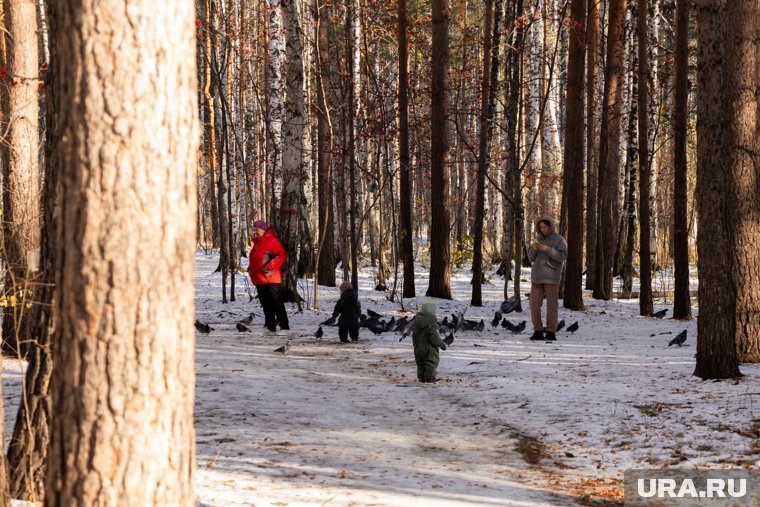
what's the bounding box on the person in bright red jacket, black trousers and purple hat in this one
[248,220,290,333]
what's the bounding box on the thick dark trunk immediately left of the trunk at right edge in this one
[694,0,741,379]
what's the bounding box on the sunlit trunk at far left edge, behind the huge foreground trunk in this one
[0,0,41,356]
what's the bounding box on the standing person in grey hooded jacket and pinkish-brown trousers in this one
[528,217,567,340]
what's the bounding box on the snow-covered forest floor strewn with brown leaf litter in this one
[3,252,760,507]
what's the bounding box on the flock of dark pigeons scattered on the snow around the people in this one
[195,296,686,354]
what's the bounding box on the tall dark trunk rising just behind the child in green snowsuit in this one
[426,0,451,299]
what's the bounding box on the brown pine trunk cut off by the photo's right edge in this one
[724,2,760,363]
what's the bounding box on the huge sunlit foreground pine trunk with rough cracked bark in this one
[46,0,199,507]
